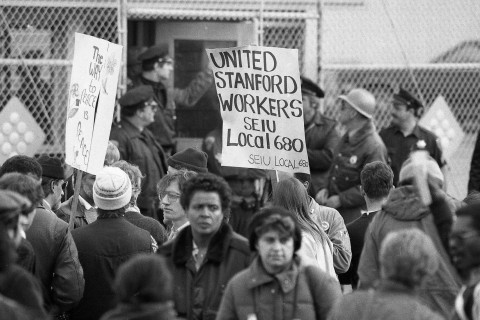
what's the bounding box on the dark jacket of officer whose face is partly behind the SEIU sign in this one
[305,112,340,194]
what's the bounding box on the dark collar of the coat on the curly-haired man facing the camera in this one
[172,222,233,265]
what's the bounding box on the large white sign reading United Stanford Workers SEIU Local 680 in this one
[207,46,310,173]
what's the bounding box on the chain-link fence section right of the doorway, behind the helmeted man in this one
[320,0,480,199]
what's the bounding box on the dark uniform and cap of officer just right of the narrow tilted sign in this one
[110,86,167,218]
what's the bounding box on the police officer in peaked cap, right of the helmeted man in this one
[380,88,445,186]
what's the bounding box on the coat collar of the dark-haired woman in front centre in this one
[247,256,299,293]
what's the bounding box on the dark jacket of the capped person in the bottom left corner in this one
[0,264,47,319]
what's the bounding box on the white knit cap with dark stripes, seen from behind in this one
[93,167,132,210]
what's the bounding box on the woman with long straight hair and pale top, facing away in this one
[272,177,337,279]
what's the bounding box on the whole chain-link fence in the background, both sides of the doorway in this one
[0,0,480,197]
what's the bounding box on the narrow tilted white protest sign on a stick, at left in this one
[65,33,123,174]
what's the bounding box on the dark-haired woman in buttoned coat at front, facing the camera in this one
[216,207,341,320]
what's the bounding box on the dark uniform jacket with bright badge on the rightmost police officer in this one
[380,124,445,186]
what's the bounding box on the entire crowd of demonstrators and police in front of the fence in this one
[0,47,480,320]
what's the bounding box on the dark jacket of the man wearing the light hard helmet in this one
[328,121,387,224]
